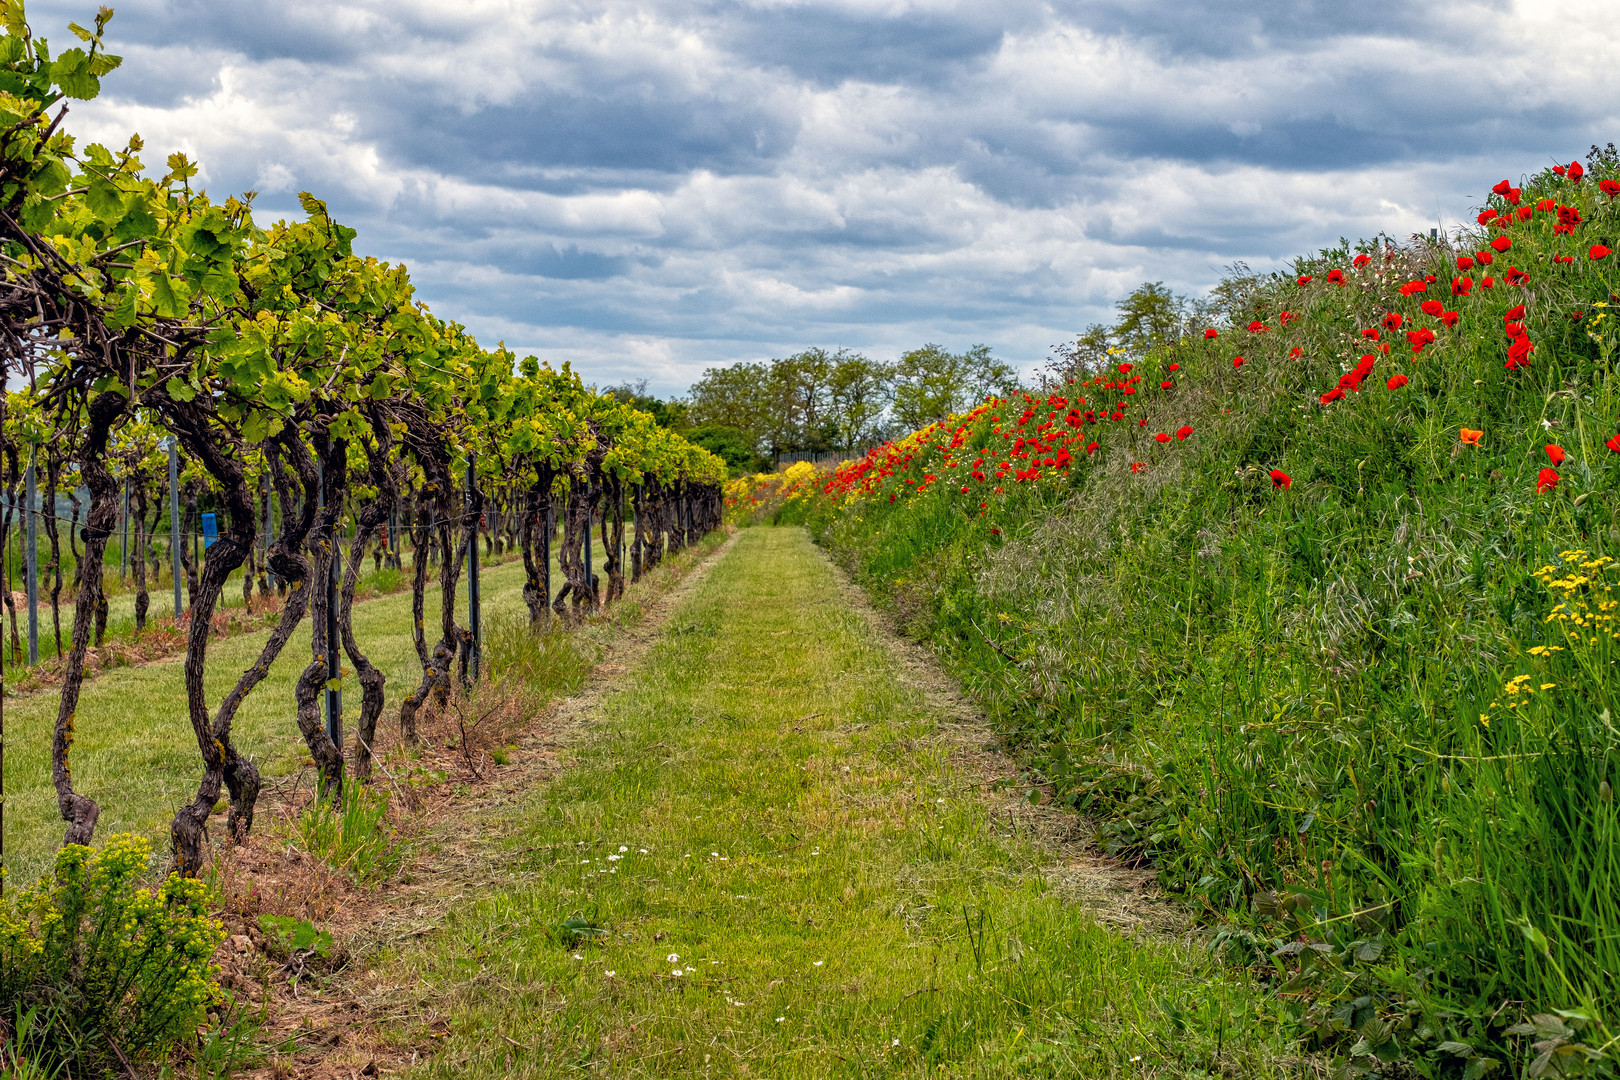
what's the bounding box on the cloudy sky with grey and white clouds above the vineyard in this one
[29,0,1620,395]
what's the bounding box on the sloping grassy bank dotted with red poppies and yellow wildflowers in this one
[764,149,1620,1077]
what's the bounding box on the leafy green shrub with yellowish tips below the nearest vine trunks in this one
[0,834,225,1075]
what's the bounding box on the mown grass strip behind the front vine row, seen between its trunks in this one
[5,562,556,887]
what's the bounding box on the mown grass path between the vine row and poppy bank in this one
[388,528,1285,1078]
